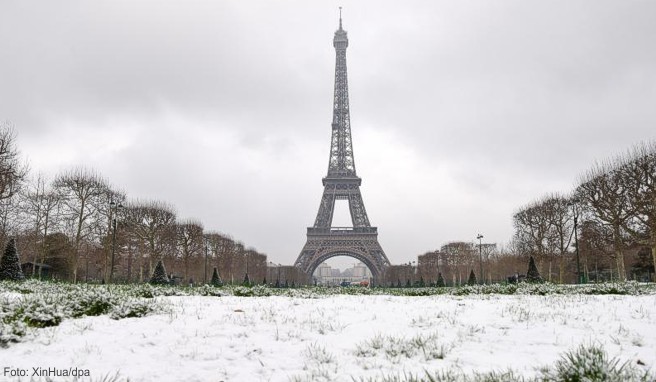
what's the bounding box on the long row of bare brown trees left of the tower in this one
[0,123,266,283]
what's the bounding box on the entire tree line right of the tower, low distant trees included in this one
[404,142,656,285]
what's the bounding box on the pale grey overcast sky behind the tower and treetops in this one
[0,0,656,264]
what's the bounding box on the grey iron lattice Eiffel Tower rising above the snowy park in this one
[294,11,390,285]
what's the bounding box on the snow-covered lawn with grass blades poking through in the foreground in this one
[0,295,656,382]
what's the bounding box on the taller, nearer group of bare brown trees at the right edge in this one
[513,143,656,282]
